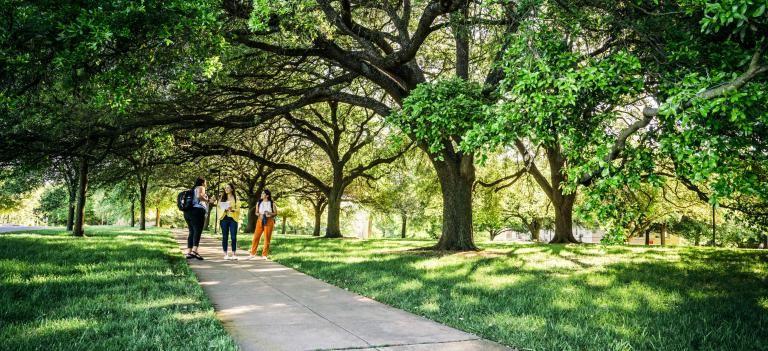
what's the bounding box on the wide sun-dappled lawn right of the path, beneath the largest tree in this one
[272,236,768,350]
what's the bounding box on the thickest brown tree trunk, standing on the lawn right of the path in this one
[430,152,477,251]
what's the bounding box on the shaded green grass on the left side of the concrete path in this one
[0,227,237,350]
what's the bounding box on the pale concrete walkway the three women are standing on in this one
[175,231,510,351]
